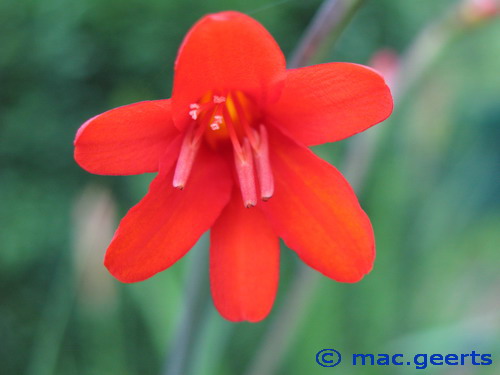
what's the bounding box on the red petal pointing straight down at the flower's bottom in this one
[210,190,279,322]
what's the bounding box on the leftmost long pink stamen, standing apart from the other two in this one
[172,125,201,190]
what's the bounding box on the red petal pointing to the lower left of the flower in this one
[104,145,233,282]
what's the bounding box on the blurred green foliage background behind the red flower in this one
[0,0,500,375]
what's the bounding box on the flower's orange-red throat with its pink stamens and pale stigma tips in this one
[173,91,274,207]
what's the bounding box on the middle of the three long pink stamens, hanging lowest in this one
[234,138,257,208]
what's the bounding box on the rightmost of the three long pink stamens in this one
[253,124,274,201]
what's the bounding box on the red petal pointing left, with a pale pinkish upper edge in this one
[74,100,179,175]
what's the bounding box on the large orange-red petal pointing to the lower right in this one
[257,130,375,282]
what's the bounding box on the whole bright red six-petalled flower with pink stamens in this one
[75,12,392,321]
